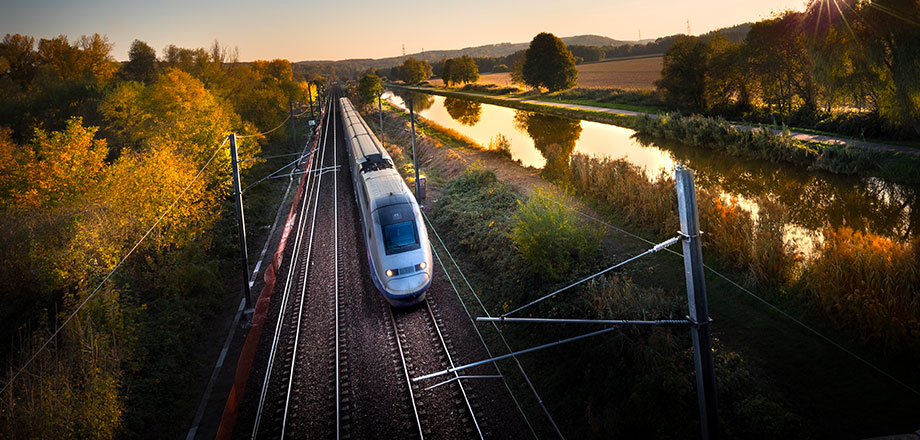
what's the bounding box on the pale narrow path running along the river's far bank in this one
[405,87,920,156]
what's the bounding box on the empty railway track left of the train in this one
[251,93,338,438]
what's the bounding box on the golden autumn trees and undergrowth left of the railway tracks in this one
[0,34,315,438]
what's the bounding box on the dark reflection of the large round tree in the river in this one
[514,110,581,180]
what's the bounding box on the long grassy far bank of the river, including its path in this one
[389,84,920,183]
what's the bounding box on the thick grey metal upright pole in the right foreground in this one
[675,168,721,439]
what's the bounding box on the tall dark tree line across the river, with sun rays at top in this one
[657,0,920,137]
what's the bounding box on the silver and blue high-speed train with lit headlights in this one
[339,98,432,306]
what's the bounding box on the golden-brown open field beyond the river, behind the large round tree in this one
[428,56,663,90]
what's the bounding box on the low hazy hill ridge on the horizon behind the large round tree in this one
[296,35,635,70]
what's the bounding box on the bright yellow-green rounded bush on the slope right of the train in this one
[511,188,603,281]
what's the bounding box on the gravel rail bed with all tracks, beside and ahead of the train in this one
[234,87,510,440]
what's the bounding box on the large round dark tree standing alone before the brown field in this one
[522,32,578,91]
